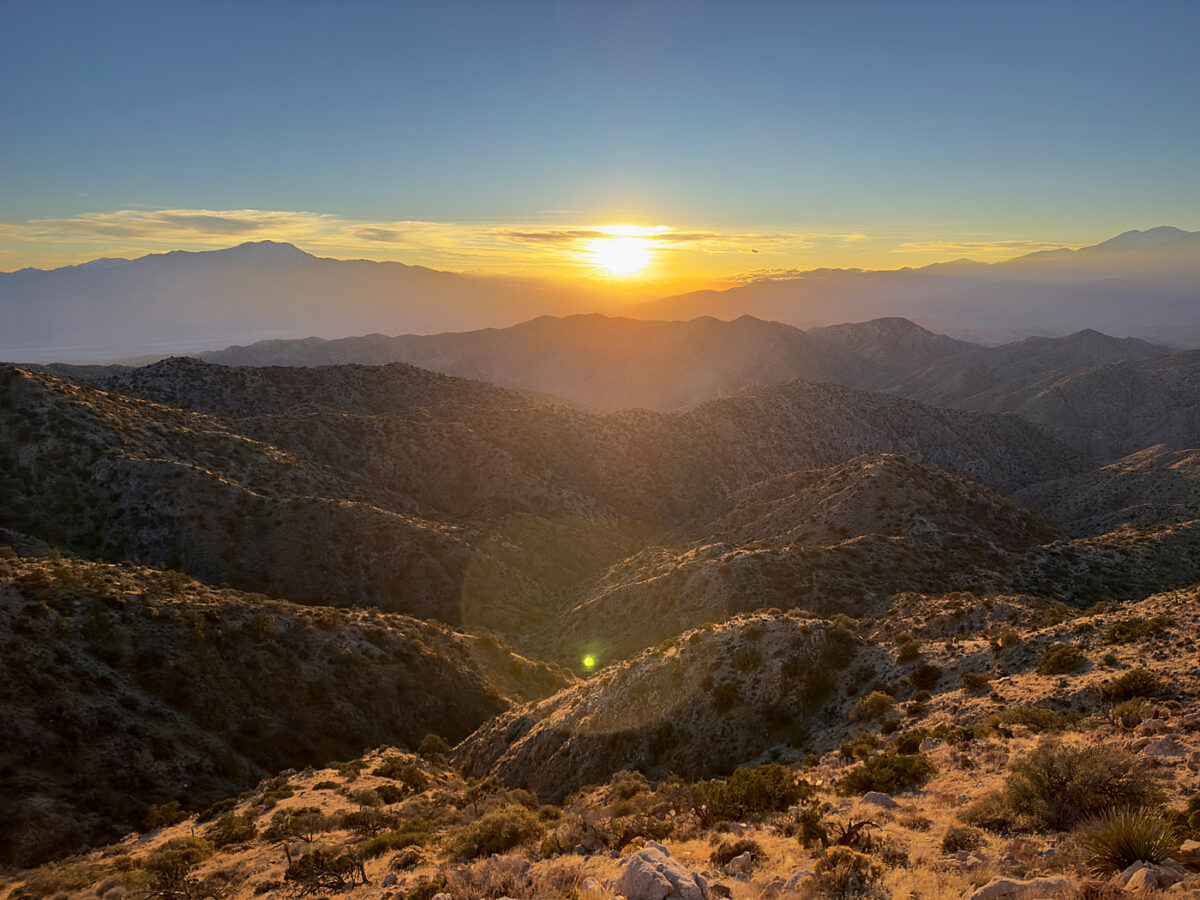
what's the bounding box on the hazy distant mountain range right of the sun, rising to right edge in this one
[625,226,1200,347]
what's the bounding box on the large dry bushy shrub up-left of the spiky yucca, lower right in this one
[1003,744,1159,830]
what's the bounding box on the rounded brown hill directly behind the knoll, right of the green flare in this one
[538,455,1055,662]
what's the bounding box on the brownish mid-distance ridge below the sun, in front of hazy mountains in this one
[201,314,1200,461]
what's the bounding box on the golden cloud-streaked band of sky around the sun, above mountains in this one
[0,209,1094,288]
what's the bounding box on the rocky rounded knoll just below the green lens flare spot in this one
[455,614,878,800]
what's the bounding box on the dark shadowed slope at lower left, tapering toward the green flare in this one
[0,554,572,865]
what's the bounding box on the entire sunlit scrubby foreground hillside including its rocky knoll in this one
[7,589,1200,900]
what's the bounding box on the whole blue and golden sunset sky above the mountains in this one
[0,0,1200,283]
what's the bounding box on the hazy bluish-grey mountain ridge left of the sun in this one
[0,241,601,361]
